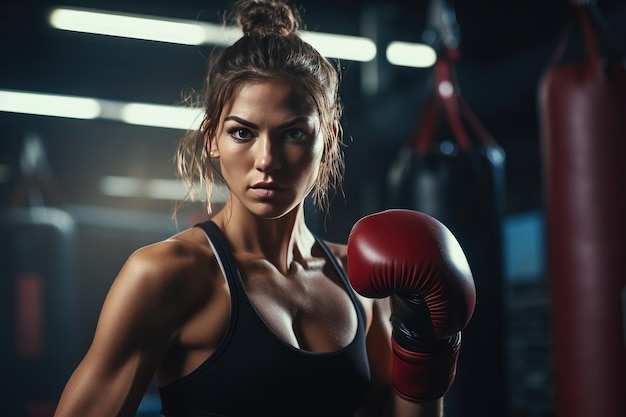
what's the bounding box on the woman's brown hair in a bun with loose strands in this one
[177,0,344,213]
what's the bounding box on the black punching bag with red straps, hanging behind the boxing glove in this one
[388,48,507,417]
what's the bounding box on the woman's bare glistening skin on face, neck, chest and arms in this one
[55,80,442,417]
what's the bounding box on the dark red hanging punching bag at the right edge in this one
[539,5,626,417]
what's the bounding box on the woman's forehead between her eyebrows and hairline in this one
[226,79,317,115]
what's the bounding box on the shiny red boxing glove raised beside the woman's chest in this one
[348,209,476,402]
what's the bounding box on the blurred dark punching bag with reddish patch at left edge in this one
[0,135,80,417]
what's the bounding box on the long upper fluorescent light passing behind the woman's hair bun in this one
[48,8,376,62]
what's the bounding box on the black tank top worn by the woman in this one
[159,221,370,417]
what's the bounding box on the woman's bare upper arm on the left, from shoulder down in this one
[56,242,205,416]
